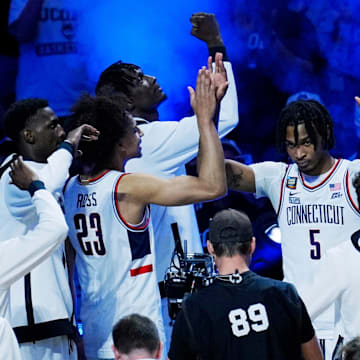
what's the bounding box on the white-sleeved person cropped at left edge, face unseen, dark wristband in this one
[0,157,68,360]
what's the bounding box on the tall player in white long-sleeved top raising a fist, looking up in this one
[96,12,238,286]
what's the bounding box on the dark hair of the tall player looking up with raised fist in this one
[95,61,141,97]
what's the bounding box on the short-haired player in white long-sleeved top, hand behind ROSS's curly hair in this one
[0,99,97,360]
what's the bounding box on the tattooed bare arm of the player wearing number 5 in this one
[225,159,256,192]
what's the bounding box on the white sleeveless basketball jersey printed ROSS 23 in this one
[64,171,163,358]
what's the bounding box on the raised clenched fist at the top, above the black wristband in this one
[190,12,224,46]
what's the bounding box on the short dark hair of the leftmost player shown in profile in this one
[4,98,49,142]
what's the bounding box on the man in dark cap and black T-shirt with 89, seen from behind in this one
[169,209,323,360]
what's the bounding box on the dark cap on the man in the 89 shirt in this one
[209,209,253,243]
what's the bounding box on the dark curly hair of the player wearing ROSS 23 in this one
[71,94,132,169]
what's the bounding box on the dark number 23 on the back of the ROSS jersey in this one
[74,213,106,255]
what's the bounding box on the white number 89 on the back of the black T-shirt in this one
[228,303,269,337]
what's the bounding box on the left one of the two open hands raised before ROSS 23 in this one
[188,66,216,126]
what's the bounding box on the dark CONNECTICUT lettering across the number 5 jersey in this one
[286,204,344,225]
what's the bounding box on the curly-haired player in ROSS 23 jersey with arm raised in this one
[64,68,227,360]
